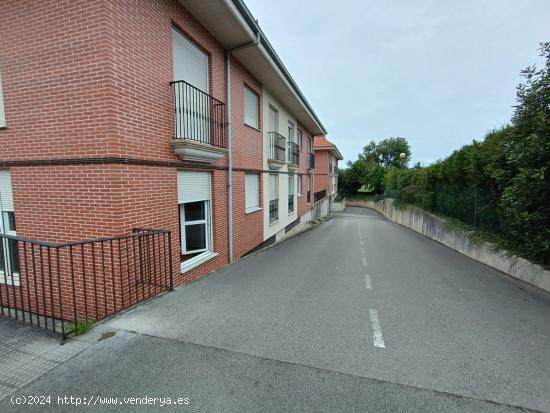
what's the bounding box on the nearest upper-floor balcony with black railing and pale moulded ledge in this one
[170,80,227,163]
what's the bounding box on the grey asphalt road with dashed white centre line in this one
[0,208,550,412]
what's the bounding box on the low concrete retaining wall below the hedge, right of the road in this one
[346,199,550,292]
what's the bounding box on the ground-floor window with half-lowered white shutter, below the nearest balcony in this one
[178,171,212,255]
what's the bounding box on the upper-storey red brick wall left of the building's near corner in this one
[0,0,117,160]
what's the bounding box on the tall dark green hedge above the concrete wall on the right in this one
[342,43,550,265]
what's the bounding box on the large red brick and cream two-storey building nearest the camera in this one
[0,0,336,322]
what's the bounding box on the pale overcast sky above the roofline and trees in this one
[245,0,550,164]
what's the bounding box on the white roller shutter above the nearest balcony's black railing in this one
[172,28,208,93]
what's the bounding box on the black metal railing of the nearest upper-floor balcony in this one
[170,80,227,148]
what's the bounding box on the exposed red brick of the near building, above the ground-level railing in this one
[0,0,311,300]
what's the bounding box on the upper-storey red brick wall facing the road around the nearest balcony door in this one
[104,0,227,165]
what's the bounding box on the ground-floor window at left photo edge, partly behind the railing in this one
[0,171,19,285]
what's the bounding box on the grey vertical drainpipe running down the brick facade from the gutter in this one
[225,30,260,262]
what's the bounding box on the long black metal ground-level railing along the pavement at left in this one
[0,230,173,337]
